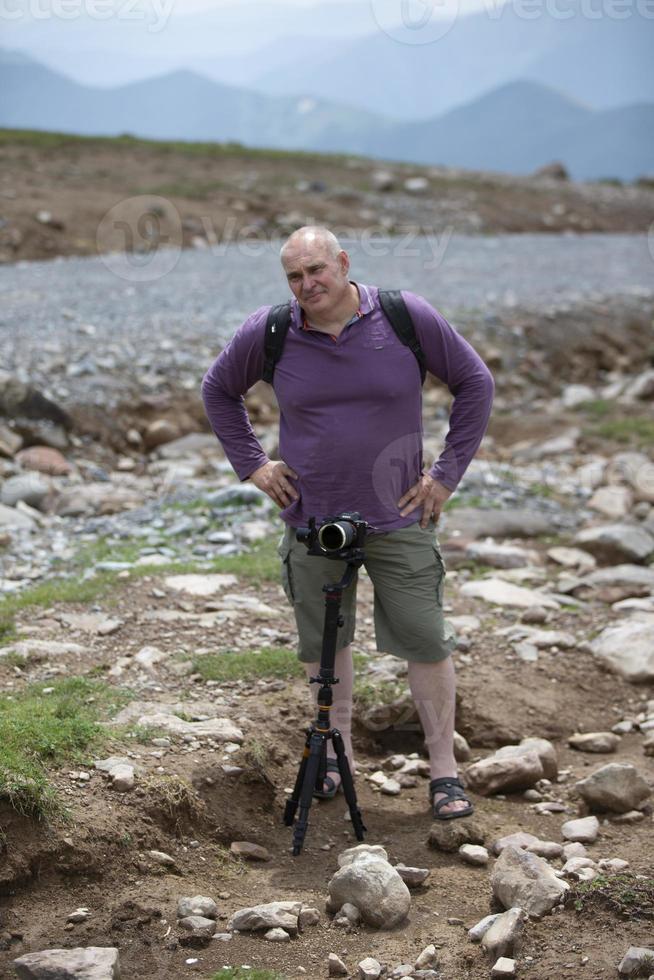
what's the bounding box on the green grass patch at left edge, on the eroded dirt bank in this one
[0,677,129,819]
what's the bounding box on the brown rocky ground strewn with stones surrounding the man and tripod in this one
[0,205,654,980]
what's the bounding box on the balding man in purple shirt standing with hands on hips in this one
[202,227,493,820]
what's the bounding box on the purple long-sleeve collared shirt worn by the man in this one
[202,284,494,531]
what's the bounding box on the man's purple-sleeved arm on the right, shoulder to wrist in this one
[402,292,495,491]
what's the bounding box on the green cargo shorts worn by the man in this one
[277,522,456,663]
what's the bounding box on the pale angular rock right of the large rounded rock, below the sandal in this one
[491,847,568,918]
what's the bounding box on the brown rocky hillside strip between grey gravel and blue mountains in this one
[0,130,654,262]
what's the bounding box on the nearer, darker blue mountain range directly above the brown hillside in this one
[0,50,654,180]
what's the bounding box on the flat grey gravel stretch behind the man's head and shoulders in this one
[0,234,654,408]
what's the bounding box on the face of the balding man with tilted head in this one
[282,241,350,316]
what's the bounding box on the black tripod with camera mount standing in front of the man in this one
[284,515,366,857]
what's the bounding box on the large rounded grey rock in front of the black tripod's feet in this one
[328,844,411,929]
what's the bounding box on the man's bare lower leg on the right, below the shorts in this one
[409,657,468,813]
